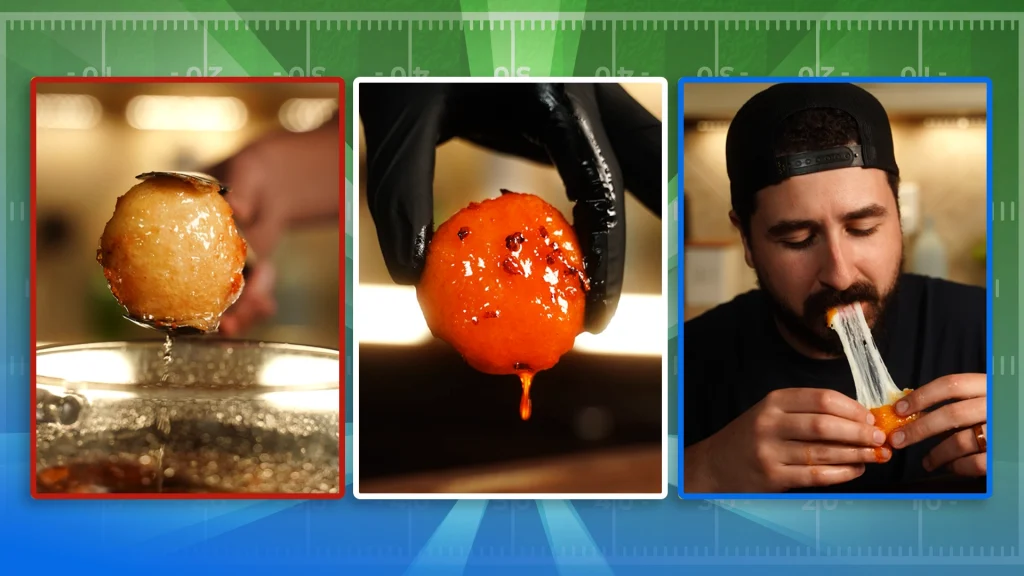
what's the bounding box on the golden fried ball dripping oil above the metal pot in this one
[96,172,247,332]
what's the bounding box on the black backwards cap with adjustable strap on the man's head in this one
[725,82,899,205]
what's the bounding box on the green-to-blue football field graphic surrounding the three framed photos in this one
[0,2,1024,574]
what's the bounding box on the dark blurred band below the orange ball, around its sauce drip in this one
[358,340,663,480]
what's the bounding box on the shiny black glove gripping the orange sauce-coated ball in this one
[358,83,663,334]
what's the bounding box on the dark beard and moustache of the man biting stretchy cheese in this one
[755,257,903,356]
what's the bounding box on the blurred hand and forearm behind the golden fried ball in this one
[206,120,341,336]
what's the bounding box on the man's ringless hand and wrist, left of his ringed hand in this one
[684,388,892,493]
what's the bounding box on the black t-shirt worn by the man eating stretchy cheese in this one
[682,274,987,492]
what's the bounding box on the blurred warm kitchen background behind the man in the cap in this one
[683,83,988,320]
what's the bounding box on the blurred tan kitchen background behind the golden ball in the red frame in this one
[36,83,339,349]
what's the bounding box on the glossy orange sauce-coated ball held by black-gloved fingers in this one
[417,191,589,377]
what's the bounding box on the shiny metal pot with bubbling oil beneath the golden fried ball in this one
[34,337,341,494]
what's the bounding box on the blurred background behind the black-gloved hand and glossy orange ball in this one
[353,82,668,493]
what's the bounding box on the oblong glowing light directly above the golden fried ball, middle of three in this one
[127,95,249,132]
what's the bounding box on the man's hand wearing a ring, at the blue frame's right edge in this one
[889,374,988,477]
